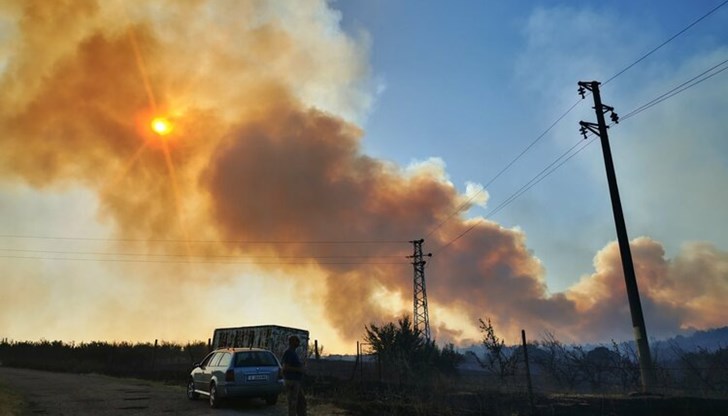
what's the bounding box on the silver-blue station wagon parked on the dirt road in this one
[187,348,283,407]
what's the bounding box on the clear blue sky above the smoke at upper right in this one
[333,1,728,291]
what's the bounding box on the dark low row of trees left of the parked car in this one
[0,340,208,382]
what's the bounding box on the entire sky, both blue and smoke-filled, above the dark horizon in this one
[0,0,728,353]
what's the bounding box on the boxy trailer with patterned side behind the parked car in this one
[212,325,308,361]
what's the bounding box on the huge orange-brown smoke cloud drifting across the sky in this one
[0,1,728,352]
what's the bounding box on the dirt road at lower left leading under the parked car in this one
[0,367,286,416]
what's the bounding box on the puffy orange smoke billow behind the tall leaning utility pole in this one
[566,237,728,338]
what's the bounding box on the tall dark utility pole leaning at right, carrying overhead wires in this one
[579,81,655,392]
